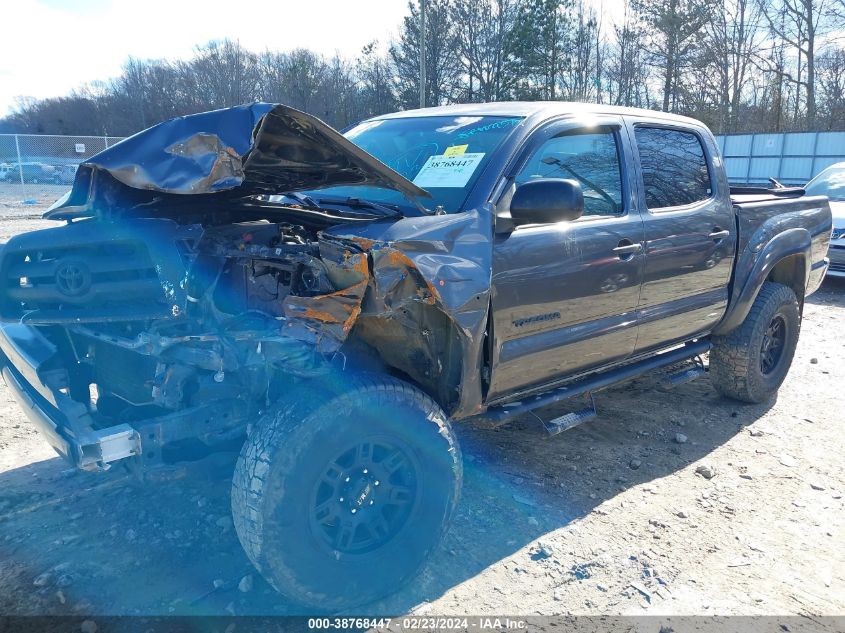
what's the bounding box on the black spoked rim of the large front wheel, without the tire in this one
[310,438,420,555]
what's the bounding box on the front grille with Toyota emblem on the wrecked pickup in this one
[0,220,192,324]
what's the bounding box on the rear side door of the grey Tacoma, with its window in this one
[629,120,736,352]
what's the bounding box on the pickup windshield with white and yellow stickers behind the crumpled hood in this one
[296,116,522,211]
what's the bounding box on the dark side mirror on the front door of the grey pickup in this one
[510,178,584,225]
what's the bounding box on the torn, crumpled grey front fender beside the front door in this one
[324,210,492,417]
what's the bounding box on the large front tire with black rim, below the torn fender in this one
[232,377,462,612]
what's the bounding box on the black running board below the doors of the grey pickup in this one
[478,340,710,427]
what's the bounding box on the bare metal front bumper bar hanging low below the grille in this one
[0,323,141,470]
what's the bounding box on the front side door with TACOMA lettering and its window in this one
[488,118,643,401]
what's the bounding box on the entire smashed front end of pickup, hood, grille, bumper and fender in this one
[0,104,490,469]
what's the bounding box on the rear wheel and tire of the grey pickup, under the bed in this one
[710,282,801,403]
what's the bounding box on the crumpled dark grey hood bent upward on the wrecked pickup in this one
[44,103,429,220]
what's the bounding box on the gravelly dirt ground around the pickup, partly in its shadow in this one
[0,188,845,619]
